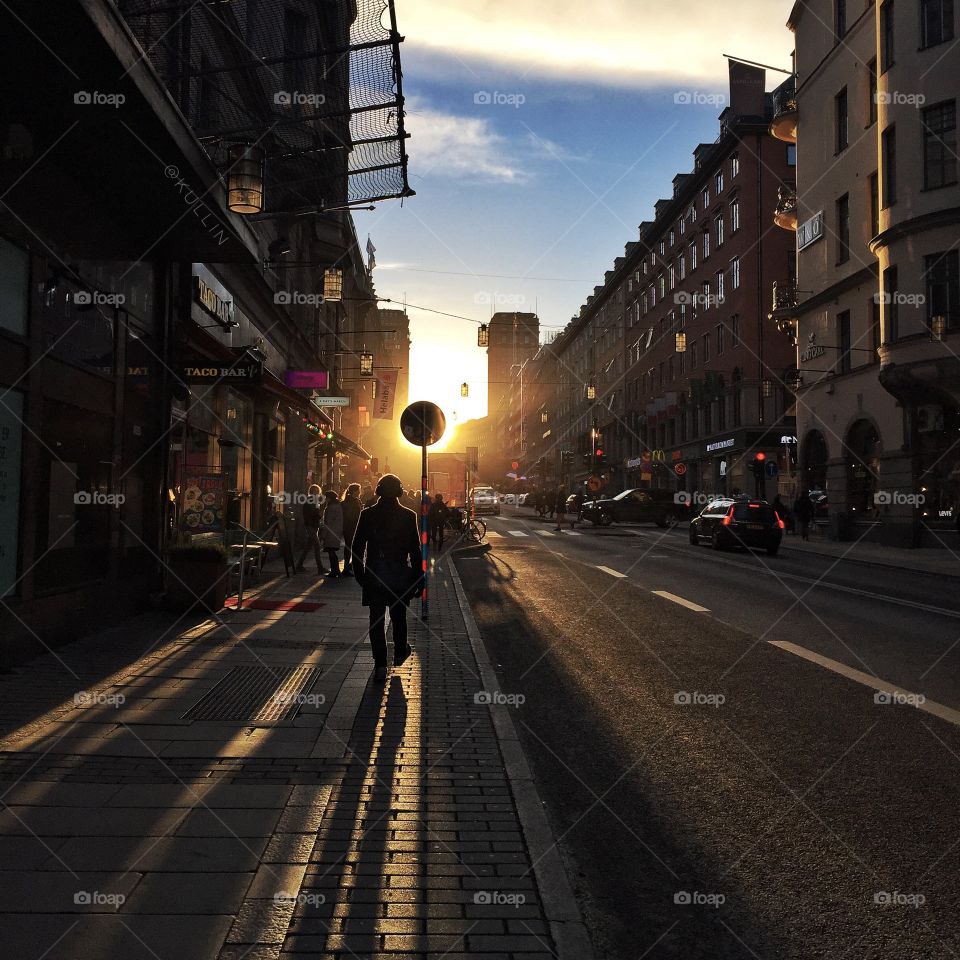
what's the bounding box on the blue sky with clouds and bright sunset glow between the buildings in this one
[355,0,793,432]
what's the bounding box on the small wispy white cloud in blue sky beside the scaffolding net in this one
[407,97,529,183]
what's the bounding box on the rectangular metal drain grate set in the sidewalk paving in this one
[182,666,321,723]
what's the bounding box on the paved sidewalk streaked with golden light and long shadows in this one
[0,559,589,960]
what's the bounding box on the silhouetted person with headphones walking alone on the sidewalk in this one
[350,473,423,683]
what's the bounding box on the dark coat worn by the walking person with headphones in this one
[350,497,422,607]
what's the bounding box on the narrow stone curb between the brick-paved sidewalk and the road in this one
[449,560,595,960]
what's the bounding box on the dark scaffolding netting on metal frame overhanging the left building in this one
[119,0,413,213]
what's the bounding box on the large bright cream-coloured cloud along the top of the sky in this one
[397,0,793,86]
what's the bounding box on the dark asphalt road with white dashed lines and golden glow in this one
[457,513,960,960]
